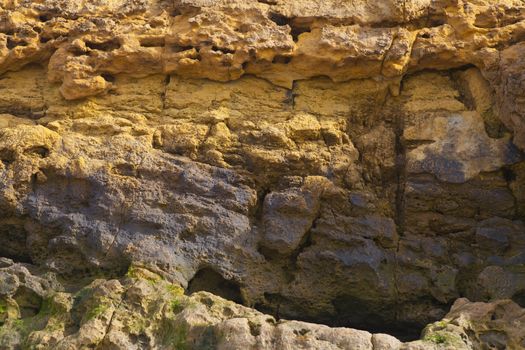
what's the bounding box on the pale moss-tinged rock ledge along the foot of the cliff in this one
[0,258,525,350]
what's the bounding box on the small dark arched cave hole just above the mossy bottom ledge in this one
[187,268,243,304]
